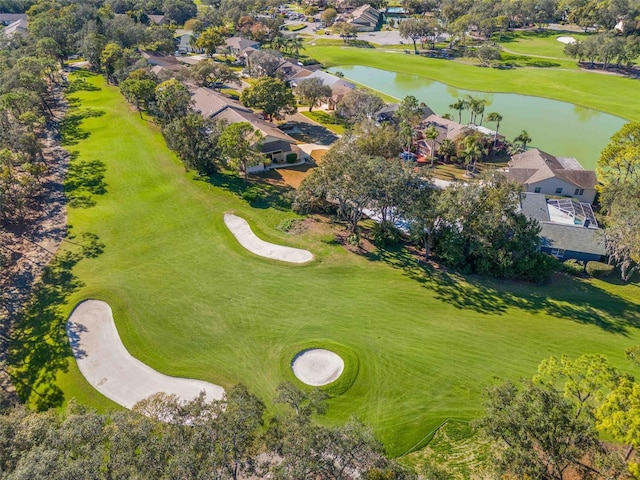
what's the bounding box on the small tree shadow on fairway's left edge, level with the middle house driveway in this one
[64,157,107,208]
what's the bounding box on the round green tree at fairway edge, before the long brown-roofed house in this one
[218,122,265,182]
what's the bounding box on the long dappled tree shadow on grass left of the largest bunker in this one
[8,234,104,411]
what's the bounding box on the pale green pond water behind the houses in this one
[330,63,626,169]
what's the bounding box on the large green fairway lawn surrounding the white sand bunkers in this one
[12,72,640,455]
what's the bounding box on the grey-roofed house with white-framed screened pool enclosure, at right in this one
[520,192,606,262]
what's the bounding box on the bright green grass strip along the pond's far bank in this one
[305,45,640,121]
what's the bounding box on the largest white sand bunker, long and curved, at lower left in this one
[67,300,224,408]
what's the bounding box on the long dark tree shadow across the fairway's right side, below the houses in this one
[366,247,640,336]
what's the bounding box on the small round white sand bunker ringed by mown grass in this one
[291,348,344,387]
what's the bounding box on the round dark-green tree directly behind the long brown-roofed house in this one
[240,77,296,120]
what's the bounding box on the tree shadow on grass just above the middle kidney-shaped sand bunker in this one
[204,174,291,210]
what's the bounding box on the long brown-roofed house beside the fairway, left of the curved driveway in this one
[192,88,307,169]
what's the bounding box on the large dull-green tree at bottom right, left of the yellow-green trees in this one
[477,382,606,480]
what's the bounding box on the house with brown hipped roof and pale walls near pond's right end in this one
[503,148,598,204]
